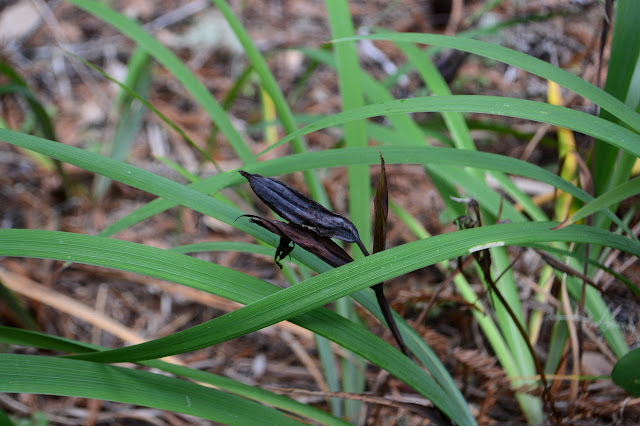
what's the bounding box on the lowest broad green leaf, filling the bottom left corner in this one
[0,354,300,425]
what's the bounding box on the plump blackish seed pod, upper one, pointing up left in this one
[240,170,363,247]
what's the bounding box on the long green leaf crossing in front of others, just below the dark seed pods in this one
[47,222,640,362]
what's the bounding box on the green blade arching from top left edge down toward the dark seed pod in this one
[69,0,254,163]
